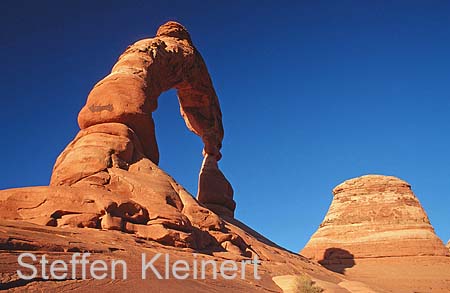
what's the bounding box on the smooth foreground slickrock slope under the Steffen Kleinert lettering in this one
[0,219,358,292]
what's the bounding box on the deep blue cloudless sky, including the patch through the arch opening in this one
[0,0,450,251]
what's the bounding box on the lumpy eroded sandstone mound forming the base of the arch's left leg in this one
[0,135,243,256]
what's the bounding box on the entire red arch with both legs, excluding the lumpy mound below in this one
[51,22,235,216]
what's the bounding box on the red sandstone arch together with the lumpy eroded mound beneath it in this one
[0,22,239,255]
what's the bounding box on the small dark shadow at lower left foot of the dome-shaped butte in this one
[319,247,355,274]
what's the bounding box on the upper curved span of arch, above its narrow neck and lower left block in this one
[78,22,223,164]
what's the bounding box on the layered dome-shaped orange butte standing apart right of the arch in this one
[301,175,448,265]
